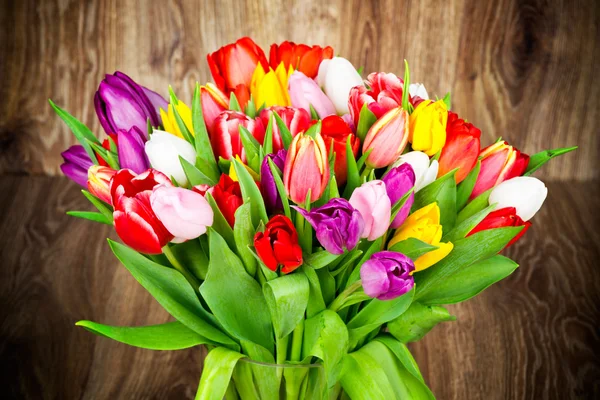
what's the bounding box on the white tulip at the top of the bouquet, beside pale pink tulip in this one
[317,57,364,114]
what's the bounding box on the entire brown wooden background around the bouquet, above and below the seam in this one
[0,0,600,400]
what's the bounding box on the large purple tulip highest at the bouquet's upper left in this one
[94,71,167,137]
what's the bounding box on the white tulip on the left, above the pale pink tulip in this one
[145,129,196,186]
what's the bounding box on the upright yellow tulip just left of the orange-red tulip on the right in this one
[408,100,448,157]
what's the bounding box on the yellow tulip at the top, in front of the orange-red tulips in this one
[250,62,294,108]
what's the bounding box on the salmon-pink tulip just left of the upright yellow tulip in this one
[363,107,409,168]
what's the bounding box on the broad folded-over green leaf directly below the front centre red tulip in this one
[263,274,310,339]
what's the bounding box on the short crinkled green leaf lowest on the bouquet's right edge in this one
[387,302,456,343]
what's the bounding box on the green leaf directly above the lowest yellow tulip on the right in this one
[412,169,457,232]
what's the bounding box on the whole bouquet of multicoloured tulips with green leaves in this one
[51,38,574,400]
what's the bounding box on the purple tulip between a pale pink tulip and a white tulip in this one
[382,163,415,229]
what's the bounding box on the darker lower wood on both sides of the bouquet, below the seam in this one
[0,177,600,400]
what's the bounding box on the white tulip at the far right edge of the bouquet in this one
[489,176,548,221]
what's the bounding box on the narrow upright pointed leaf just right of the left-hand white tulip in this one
[192,82,221,182]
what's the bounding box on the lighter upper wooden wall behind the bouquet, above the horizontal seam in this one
[0,0,600,180]
